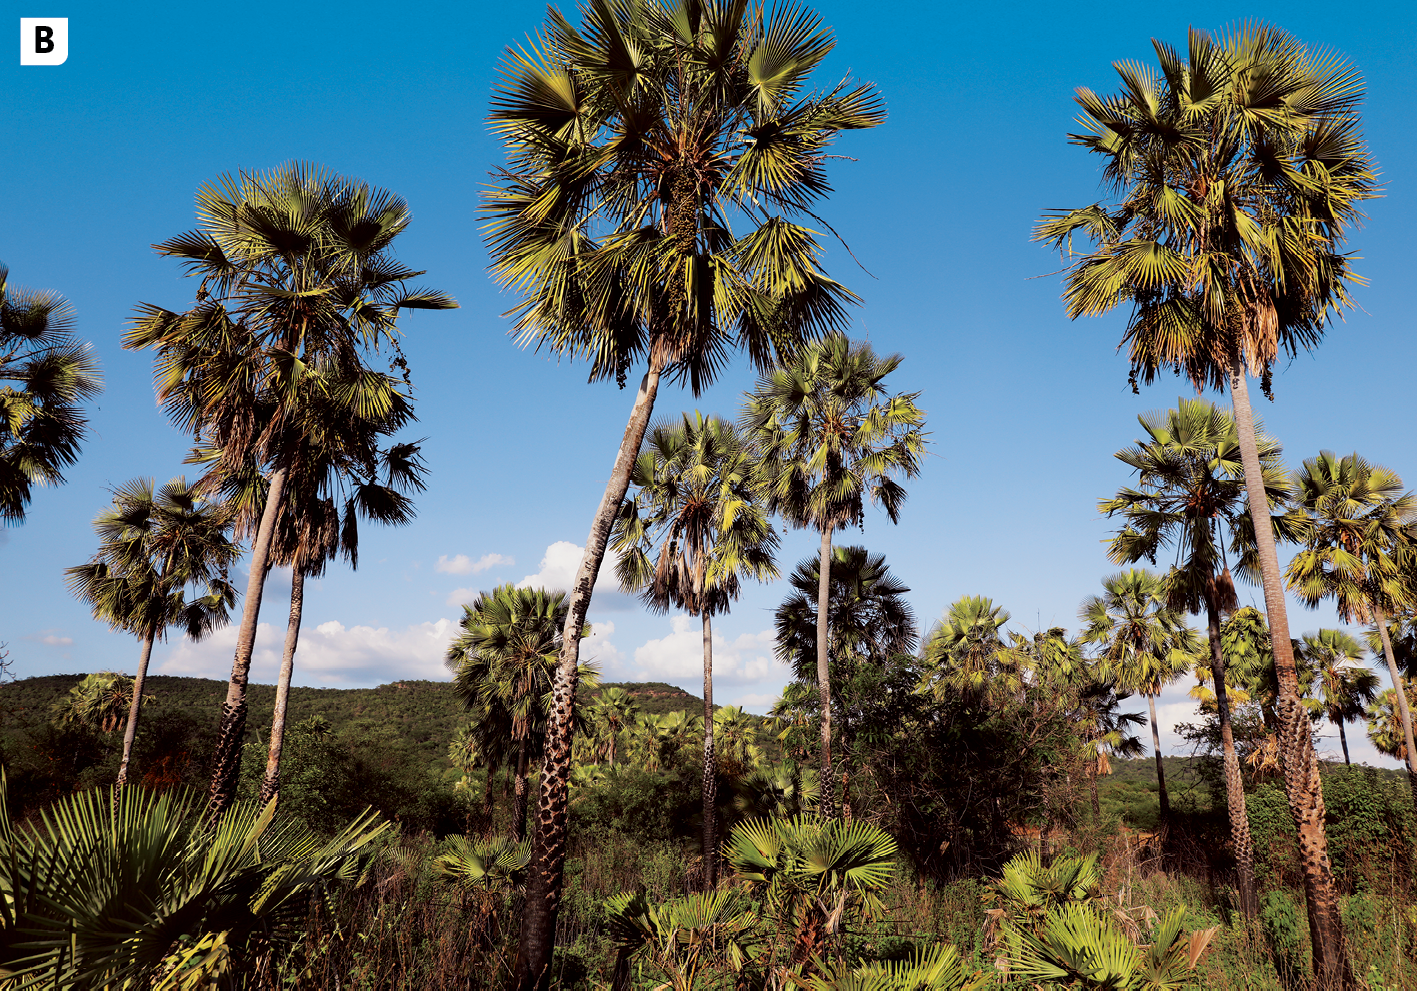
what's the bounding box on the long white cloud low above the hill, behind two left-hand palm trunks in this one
[157,618,456,687]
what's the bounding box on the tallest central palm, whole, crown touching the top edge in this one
[486,0,886,983]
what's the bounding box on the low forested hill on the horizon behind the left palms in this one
[0,675,703,765]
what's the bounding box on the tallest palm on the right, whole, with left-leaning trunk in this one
[1036,21,1377,986]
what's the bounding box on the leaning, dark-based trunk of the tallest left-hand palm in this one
[207,468,286,823]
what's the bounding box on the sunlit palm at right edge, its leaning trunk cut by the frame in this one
[1284,451,1417,808]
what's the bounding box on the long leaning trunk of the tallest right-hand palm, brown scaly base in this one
[1230,353,1353,989]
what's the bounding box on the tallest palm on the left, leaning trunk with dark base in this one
[123,164,456,818]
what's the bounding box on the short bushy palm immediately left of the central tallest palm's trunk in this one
[448,584,595,840]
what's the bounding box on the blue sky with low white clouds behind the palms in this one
[0,0,1417,760]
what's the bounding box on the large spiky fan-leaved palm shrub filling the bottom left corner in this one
[0,775,388,989]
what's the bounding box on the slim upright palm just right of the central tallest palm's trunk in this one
[611,411,778,889]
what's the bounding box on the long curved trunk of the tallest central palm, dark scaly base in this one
[513,347,666,988]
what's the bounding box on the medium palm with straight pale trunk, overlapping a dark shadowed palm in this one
[740,333,925,816]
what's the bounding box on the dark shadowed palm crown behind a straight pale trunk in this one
[774,546,920,808]
